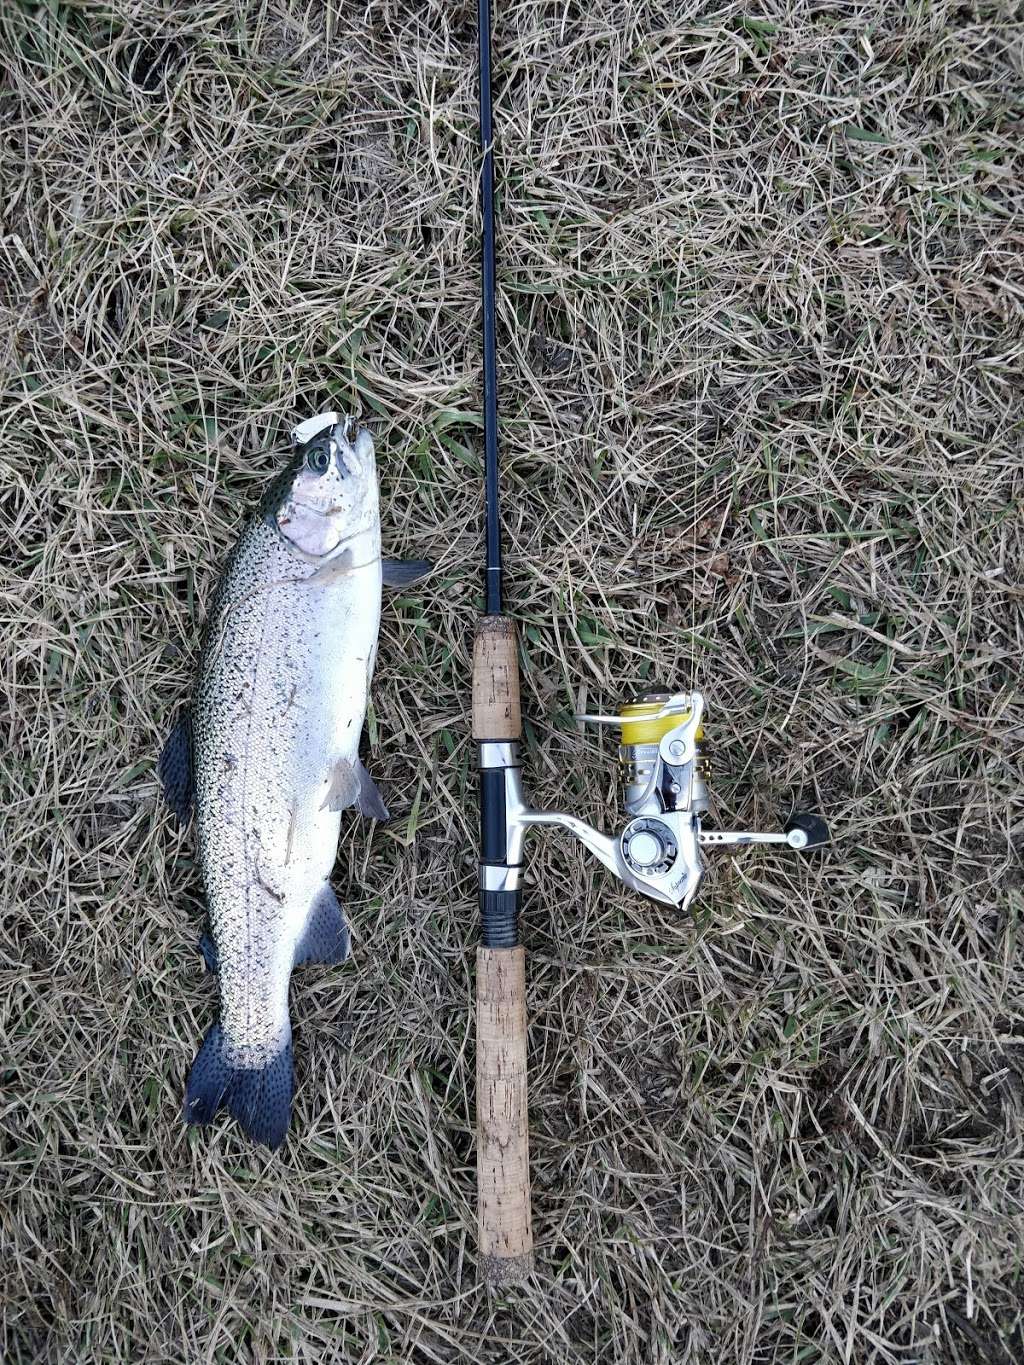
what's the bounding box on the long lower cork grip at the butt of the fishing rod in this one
[477,947,534,1286]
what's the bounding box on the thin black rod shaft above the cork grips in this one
[478,0,502,616]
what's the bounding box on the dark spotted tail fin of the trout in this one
[184,1024,294,1147]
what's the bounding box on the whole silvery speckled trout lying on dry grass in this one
[158,412,429,1147]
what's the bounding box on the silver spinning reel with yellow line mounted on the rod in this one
[481,691,829,928]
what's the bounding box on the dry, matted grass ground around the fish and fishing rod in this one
[0,0,1024,1365]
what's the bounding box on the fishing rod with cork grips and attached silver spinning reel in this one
[472,0,829,1286]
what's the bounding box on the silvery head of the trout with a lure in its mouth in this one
[270,414,380,560]
